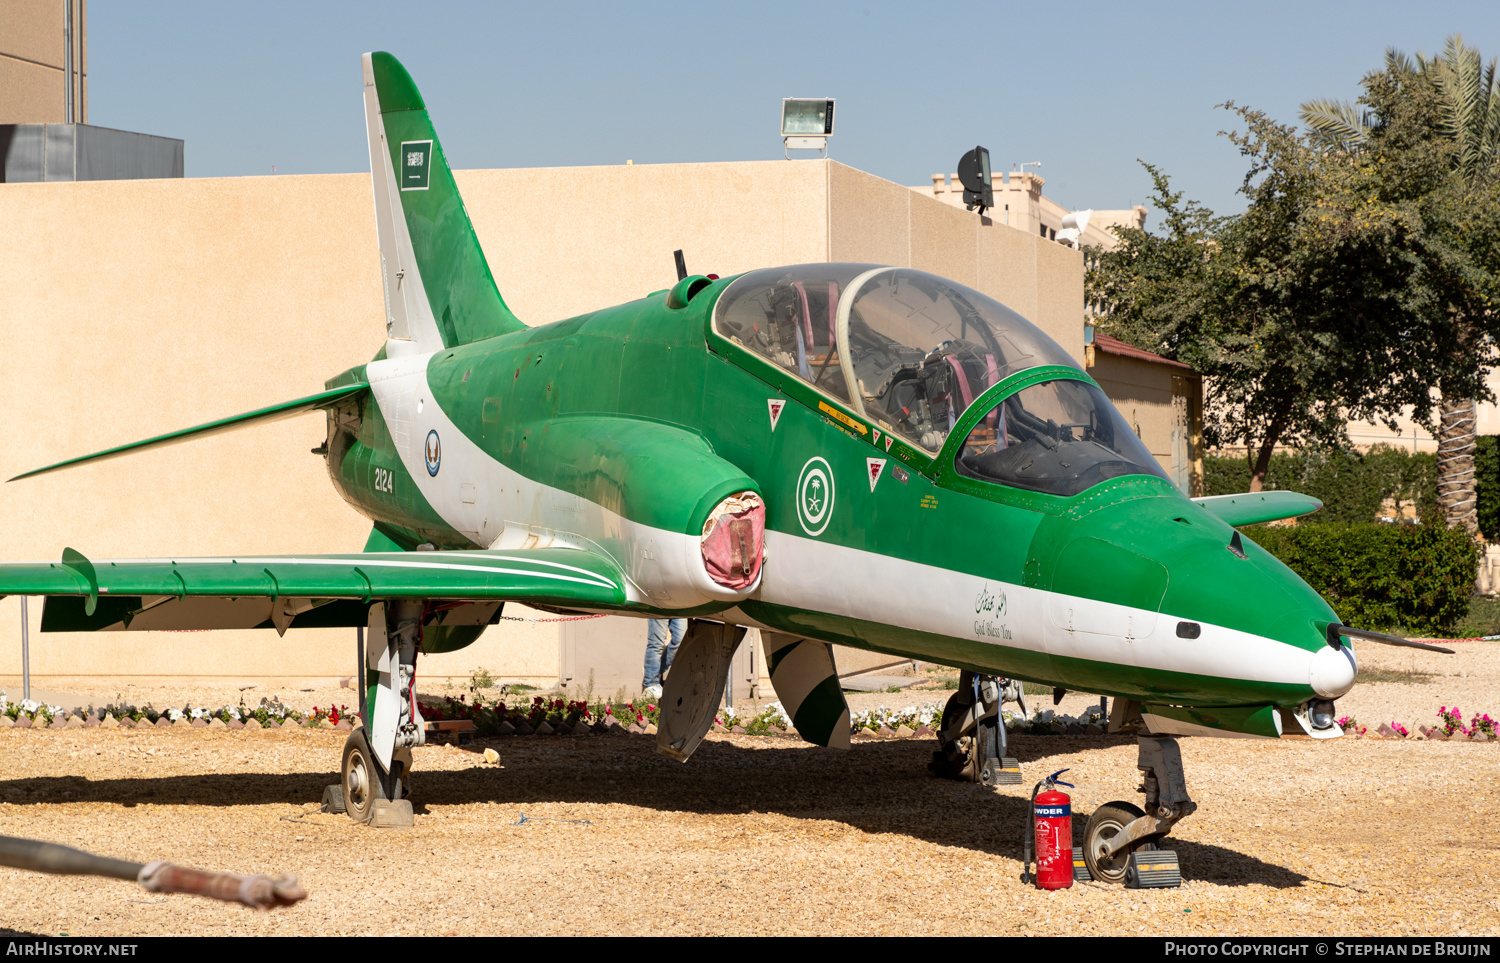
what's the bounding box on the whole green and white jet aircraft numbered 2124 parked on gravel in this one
[0,53,1452,881]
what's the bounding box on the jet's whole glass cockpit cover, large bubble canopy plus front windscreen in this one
[714,264,1166,495]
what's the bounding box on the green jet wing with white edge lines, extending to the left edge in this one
[0,548,626,632]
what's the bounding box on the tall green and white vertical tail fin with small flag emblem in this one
[363,53,527,351]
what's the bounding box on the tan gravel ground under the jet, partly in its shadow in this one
[0,642,1500,936]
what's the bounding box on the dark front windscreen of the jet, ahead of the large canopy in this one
[954,381,1167,495]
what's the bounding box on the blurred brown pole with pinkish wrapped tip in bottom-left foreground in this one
[0,836,308,909]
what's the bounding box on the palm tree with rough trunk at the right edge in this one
[1302,35,1500,534]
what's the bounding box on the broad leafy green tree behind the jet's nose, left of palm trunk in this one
[1088,104,1455,491]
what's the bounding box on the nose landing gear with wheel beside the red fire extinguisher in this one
[1083,735,1199,885]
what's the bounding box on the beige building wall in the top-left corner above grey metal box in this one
[0,0,89,125]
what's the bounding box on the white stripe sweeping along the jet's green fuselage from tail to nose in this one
[368,356,1311,686]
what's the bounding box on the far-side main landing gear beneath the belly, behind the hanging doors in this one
[927,672,1025,786]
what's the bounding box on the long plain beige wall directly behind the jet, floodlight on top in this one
[0,153,1083,684]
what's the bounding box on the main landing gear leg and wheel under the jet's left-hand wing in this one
[323,599,425,828]
